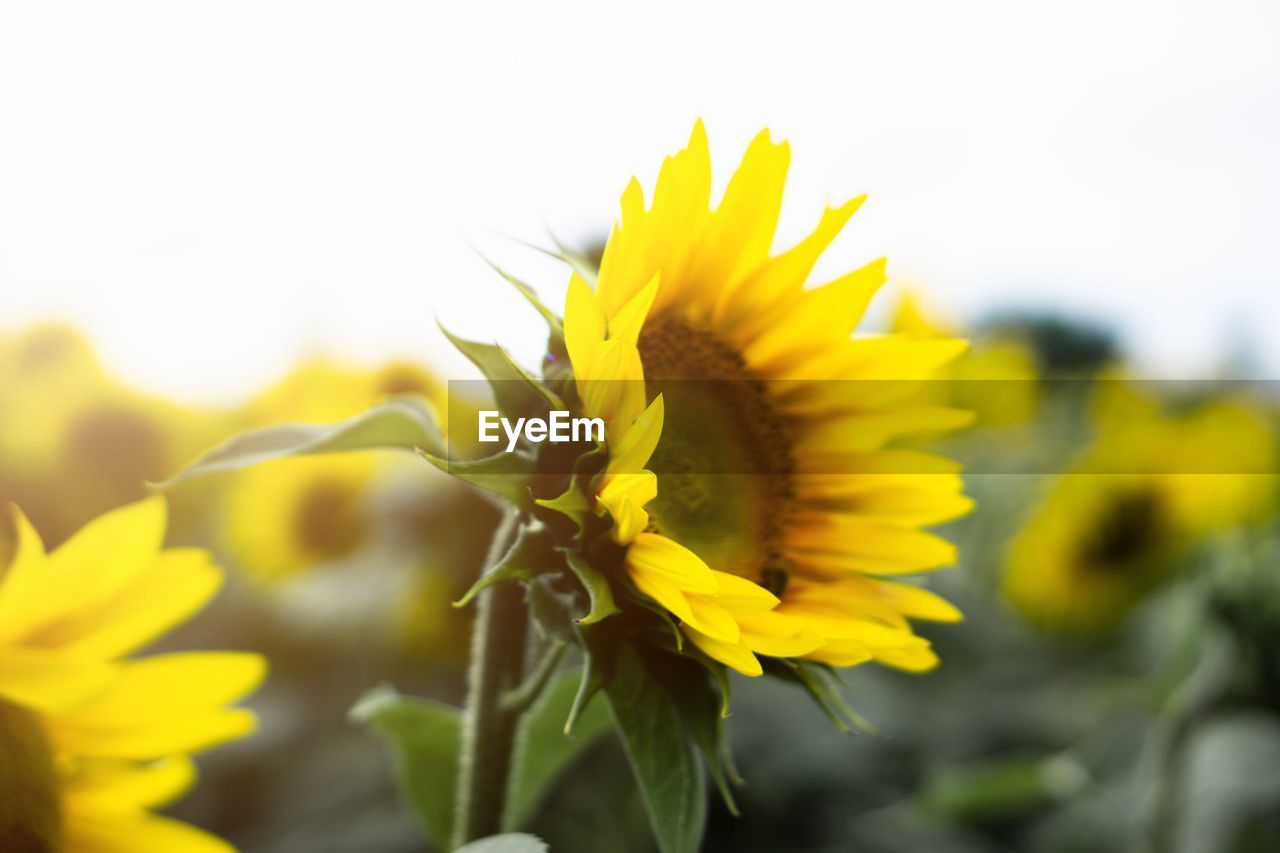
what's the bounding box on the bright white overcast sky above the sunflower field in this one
[0,0,1280,400]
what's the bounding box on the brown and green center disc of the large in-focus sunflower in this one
[640,308,795,580]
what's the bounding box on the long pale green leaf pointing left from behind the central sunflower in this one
[155,396,444,489]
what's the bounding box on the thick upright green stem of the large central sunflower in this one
[453,514,529,847]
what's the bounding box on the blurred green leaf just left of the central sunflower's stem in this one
[351,686,462,847]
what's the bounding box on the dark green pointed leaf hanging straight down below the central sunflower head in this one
[604,643,707,853]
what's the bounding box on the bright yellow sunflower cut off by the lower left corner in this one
[0,498,265,853]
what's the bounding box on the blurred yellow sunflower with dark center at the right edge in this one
[1004,383,1276,634]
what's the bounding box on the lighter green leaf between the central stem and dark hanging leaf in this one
[506,670,613,826]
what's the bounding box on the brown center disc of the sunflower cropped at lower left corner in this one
[0,699,64,853]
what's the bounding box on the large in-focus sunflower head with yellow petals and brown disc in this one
[564,123,970,675]
